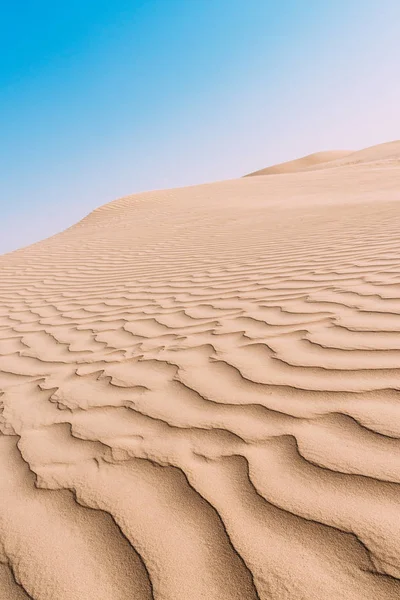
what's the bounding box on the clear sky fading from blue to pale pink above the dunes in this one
[0,0,400,253]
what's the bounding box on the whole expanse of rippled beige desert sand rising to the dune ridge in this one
[0,142,400,600]
